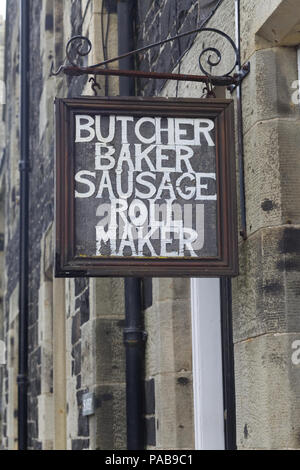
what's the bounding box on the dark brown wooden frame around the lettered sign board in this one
[55,97,238,277]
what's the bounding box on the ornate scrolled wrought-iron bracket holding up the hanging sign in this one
[50,28,250,91]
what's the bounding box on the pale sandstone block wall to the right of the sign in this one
[158,0,300,449]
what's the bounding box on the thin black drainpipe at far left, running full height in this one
[18,0,29,450]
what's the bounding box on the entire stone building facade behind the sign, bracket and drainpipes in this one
[0,0,300,450]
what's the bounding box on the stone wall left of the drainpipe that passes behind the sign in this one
[1,0,126,450]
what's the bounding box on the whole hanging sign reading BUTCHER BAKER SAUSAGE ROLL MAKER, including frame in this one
[56,98,237,277]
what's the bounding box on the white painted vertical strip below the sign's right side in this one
[191,278,225,450]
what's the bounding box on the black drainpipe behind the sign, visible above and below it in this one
[118,0,145,450]
